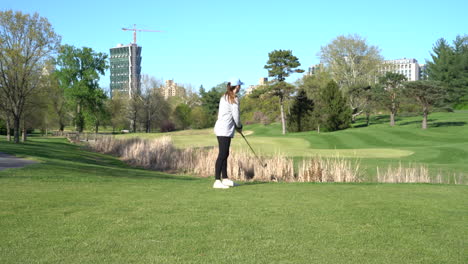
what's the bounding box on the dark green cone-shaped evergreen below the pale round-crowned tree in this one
[315,81,351,131]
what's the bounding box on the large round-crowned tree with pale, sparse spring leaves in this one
[319,35,383,120]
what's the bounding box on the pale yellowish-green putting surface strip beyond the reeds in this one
[119,129,414,158]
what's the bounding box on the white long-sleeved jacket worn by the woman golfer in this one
[214,95,242,137]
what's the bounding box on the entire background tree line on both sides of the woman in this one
[0,10,468,142]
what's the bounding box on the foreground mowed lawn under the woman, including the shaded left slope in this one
[0,138,468,263]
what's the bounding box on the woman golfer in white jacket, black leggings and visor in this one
[213,79,244,189]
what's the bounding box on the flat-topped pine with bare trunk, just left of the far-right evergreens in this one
[404,81,446,129]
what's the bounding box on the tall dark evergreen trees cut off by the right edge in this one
[427,35,468,106]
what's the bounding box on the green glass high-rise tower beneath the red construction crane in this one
[110,43,141,97]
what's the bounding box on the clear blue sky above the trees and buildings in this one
[0,0,468,91]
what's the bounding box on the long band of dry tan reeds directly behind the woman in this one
[90,136,359,182]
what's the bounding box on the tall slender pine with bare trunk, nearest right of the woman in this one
[264,50,304,135]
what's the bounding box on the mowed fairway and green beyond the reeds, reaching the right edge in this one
[119,111,468,178]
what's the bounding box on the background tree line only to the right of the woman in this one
[243,35,468,134]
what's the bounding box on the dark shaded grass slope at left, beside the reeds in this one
[0,138,197,181]
